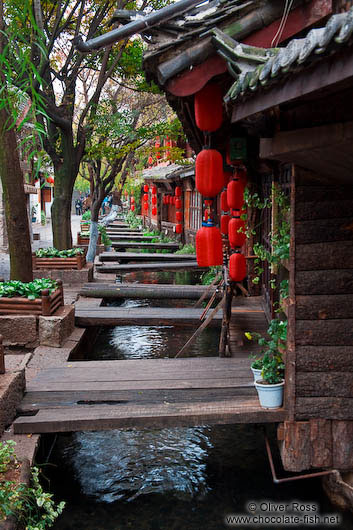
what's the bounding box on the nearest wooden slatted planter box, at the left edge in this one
[0,280,64,316]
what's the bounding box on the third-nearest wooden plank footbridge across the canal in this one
[79,280,220,300]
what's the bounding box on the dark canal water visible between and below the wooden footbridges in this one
[43,270,353,530]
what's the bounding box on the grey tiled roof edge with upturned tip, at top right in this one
[213,7,353,102]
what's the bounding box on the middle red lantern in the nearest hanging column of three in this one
[195,149,224,197]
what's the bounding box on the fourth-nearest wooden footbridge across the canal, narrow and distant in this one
[96,260,202,274]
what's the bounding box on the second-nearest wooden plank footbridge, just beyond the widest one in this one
[75,304,222,327]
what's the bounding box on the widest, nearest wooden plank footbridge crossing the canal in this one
[14,357,285,434]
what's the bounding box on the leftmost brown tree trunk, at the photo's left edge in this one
[0,11,33,282]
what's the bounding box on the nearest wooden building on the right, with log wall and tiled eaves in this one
[137,0,353,471]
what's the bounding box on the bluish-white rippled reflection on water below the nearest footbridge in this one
[65,428,211,503]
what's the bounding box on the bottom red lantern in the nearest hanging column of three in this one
[196,223,223,267]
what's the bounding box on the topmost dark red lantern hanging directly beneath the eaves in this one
[194,83,223,132]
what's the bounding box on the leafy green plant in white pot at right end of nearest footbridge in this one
[245,319,287,409]
